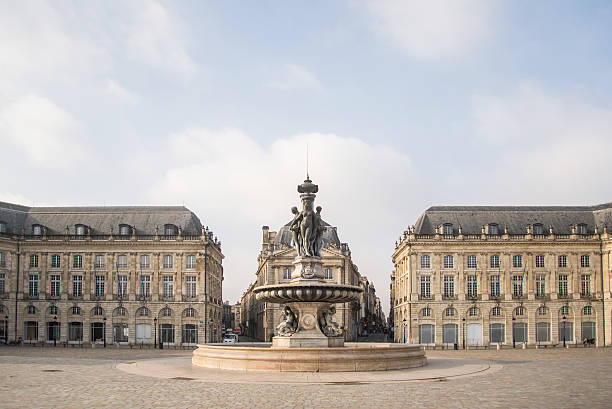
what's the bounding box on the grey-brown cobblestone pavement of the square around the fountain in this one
[0,347,612,409]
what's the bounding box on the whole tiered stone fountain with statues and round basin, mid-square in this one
[192,176,426,372]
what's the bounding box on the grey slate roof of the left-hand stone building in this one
[0,202,202,235]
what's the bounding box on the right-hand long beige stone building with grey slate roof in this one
[391,203,612,347]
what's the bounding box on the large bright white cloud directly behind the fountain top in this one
[145,129,420,305]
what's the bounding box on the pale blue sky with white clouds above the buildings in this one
[0,0,612,313]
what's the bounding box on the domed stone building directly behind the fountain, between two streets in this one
[240,222,360,341]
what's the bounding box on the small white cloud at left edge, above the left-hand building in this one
[0,95,86,168]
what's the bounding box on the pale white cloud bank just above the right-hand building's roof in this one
[472,83,612,204]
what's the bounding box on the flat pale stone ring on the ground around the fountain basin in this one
[117,357,502,385]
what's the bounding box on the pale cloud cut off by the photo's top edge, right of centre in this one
[365,0,494,60]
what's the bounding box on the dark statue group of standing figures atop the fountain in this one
[290,199,325,257]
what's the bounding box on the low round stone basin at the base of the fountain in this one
[192,342,427,372]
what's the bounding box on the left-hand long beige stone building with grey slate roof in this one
[0,202,223,345]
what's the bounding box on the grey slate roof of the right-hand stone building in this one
[415,203,612,234]
